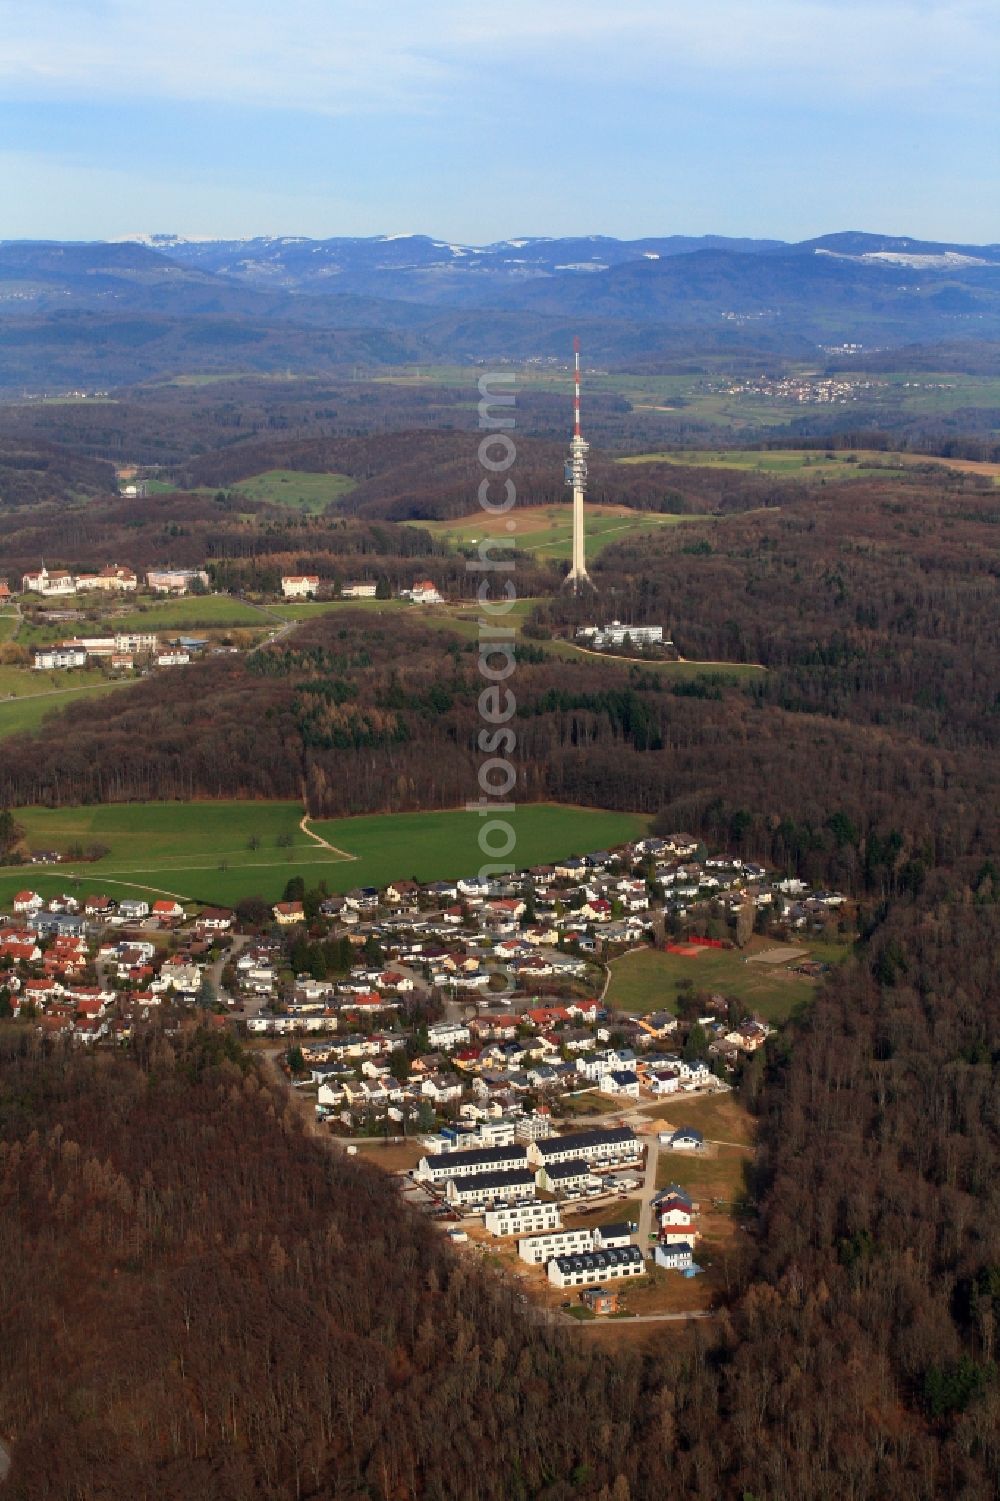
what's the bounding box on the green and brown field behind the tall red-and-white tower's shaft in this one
[411,501,713,560]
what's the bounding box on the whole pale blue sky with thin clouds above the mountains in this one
[0,0,1000,245]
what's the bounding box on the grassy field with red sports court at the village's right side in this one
[608,938,845,1022]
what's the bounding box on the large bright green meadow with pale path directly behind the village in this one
[0,802,647,905]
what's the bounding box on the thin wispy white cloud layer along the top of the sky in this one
[0,0,1000,116]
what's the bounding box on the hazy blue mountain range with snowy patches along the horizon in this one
[0,231,1000,389]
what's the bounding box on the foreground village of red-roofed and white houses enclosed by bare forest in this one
[0,833,851,1318]
